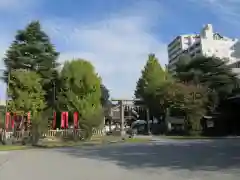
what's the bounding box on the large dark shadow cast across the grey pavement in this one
[55,140,240,171]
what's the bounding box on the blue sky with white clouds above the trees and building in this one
[0,0,240,99]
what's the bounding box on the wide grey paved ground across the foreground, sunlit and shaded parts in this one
[0,139,240,180]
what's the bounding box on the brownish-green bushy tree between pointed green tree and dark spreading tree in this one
[156,81,208,133]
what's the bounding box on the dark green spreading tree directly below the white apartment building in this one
[176,56,239,111]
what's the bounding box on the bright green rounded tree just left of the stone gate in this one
[58,59,103,136]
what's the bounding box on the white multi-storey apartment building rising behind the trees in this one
[168,24,239,73]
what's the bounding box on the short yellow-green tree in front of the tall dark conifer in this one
[8,69,47,145]
